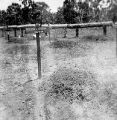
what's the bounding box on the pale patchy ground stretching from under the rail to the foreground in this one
[0,27,117,120]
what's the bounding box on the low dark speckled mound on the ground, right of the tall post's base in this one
[44,68,98,102]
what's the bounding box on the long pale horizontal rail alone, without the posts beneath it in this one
[0,21,116,30]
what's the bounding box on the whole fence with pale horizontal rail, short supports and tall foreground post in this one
[0,21,117,79]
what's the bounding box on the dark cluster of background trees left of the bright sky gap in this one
[0,0,53,25]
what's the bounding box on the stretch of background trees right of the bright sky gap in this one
[56,0,117,24]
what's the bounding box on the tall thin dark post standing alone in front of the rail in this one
[36,32,41,79]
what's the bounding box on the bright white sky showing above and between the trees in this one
[0,0,64,12]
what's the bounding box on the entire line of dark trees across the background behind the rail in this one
[0,0,117,25]
